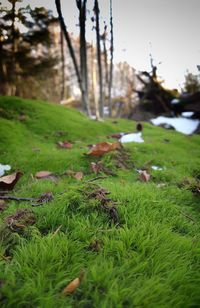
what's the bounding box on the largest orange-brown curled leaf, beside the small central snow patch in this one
[87,142,122,156]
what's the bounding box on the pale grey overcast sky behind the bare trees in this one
[2,0,200,89]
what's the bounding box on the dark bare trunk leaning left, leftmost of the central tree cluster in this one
[55,0,88,114]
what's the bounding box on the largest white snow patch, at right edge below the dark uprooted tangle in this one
[151,116,200,135]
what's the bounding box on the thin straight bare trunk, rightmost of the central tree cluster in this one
[108,0,114,117]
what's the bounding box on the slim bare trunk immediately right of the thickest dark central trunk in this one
[94,0,104,117]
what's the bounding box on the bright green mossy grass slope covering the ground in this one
[0,98,200,308]
